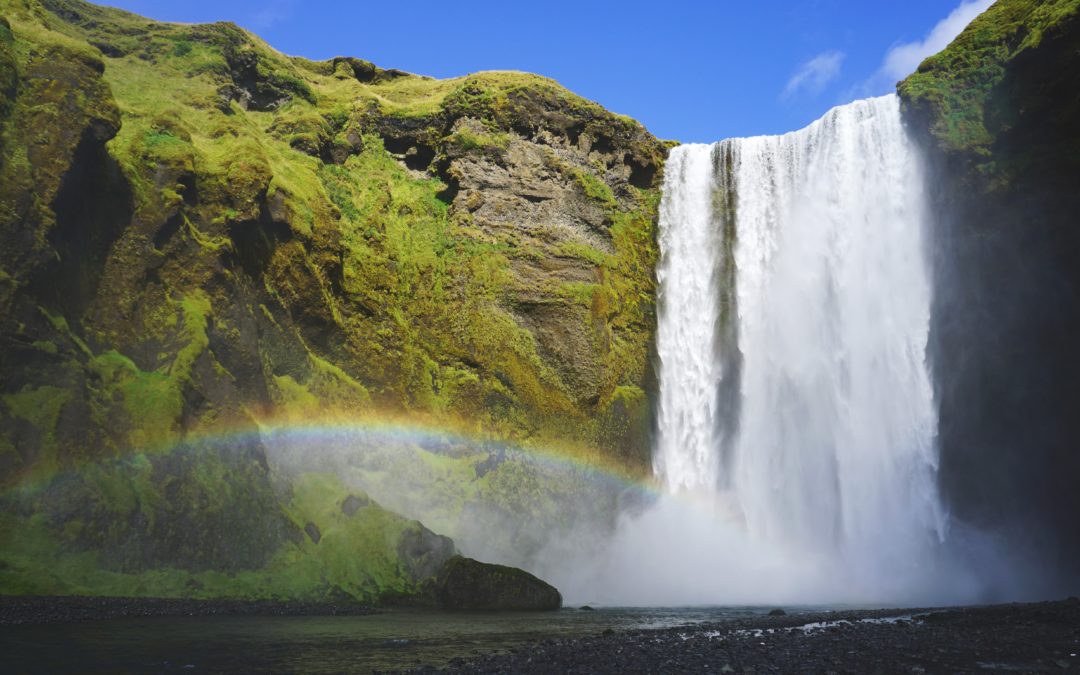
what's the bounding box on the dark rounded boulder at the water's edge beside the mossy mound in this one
[433,555,563,610]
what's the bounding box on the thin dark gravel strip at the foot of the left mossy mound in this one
[0,595,375,625]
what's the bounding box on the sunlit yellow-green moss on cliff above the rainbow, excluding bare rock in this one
[2,0,651,462]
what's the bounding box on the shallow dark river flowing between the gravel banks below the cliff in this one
[0,607,790,673]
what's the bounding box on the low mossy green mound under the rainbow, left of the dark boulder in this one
[0,460,457,604]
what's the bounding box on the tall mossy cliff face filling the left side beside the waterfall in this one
[0,0,665,595]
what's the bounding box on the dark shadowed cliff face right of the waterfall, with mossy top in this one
[899,0,1080,591]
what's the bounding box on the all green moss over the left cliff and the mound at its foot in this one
[0,0,656,598]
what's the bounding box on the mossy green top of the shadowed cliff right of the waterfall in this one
[897,0,1080,189]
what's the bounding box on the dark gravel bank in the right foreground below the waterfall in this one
[418,598,1080,673]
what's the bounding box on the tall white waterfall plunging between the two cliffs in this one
[616,96,967,603]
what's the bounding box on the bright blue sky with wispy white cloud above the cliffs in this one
[97,0,989,141]
